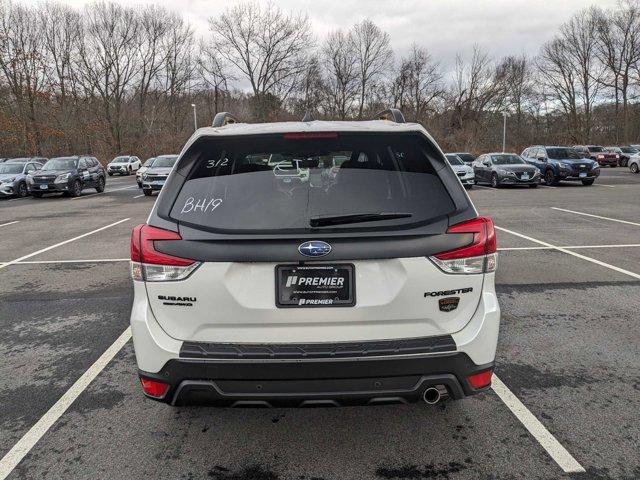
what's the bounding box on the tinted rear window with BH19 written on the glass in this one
[170,134,455,232]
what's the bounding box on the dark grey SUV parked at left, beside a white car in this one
[27,155,107,198]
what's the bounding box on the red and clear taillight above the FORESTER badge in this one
[429,217,498,274]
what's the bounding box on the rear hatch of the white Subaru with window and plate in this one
[141,132,486,343]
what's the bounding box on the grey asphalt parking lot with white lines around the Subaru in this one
[0,168,640,480]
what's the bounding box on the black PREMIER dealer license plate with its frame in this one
[275,263,356,308]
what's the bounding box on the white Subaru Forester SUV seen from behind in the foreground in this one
[131,110,500,406]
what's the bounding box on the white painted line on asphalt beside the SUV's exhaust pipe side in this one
[491,375,585,473]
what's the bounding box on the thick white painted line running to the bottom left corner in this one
[0,327,131,480]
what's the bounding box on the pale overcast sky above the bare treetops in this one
[37,0,616,74]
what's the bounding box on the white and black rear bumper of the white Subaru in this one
[131,274,500,406]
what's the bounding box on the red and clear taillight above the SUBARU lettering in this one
[131,224,200,282]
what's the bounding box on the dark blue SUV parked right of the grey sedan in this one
[521,145,600,186]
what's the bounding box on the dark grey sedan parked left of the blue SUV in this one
[473,153,540,188]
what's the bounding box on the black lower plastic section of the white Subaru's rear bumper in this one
[139,352,493,407]
